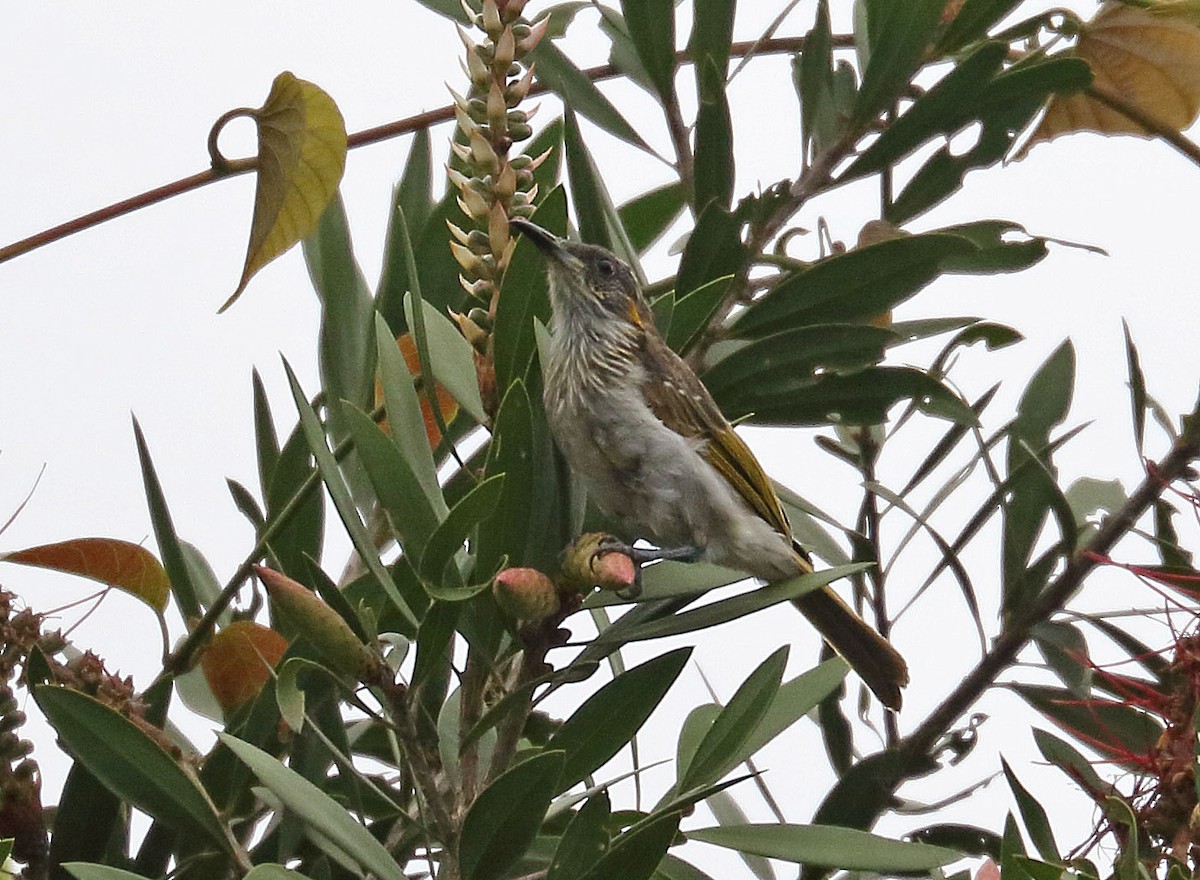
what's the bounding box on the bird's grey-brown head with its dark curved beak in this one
[509,218,654,330]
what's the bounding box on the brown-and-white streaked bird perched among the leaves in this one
[510,218,908,711]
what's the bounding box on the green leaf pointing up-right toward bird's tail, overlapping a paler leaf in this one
[678,645,788,791]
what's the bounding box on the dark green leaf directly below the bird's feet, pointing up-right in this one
[546,647,691,792]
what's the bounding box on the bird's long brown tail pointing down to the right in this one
[793,566,908,711]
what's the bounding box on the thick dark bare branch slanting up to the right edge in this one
[899,402,1200,759]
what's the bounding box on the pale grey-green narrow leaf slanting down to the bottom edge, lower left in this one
[217,732,404,880]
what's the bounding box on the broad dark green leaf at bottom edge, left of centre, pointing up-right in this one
[458,752,563,880]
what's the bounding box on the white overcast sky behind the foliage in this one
[0,0,1200,864]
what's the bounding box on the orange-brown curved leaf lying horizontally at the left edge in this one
[0,538,170,613]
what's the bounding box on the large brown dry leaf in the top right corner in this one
[1016,2,1200,158]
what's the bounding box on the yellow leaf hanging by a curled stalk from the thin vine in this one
[221,71,346,311]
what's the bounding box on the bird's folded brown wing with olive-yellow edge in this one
[642,333,792,535]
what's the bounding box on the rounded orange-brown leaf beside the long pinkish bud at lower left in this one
[200,621,288,718]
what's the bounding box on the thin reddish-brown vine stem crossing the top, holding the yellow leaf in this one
[0,35,851,263]
